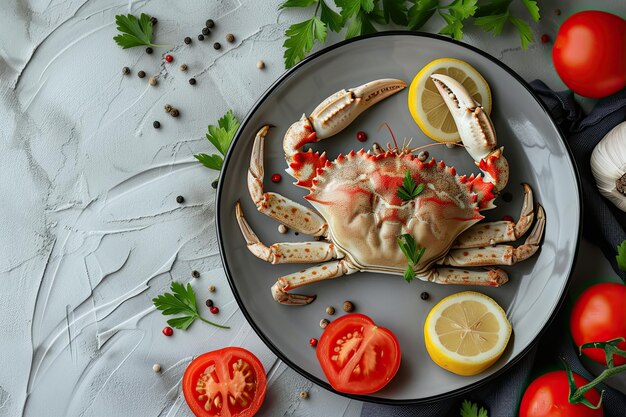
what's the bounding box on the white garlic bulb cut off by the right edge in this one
[591,122,626,211]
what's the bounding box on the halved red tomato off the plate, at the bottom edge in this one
[183,347,266,417]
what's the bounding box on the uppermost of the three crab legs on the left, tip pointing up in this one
[248,125,328,236]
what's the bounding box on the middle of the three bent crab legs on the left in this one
[235,202,343,264]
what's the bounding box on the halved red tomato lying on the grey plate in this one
[316,314,400,394]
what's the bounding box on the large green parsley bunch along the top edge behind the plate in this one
[280,0,539,68]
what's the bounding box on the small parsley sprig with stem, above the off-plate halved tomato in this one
[152,281,230,330]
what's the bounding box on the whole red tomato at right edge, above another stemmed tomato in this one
[570,282,626,365]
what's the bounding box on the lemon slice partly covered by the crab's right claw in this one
[409,58,491,142]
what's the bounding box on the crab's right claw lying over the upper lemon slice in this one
[430,74,509,191]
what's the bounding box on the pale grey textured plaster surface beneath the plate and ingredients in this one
[0,0,626,417]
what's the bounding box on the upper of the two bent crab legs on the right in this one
[452,184,532,248]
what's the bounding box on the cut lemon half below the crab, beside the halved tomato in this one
[424,291,511,376]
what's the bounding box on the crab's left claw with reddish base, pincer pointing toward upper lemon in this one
[283,79,406,187]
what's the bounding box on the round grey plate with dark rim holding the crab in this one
[217,32,581,404]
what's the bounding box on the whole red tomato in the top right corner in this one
[552,10,626,98]
